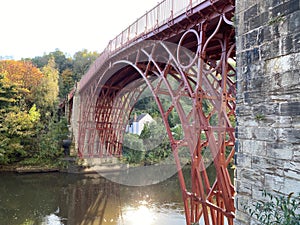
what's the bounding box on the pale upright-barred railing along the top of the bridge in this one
[79,0,208,89]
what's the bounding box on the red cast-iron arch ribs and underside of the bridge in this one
[78,1,236,225]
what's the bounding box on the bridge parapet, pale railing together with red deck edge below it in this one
[78,0,234,92]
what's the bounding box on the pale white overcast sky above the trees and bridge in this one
[0,0,160,59]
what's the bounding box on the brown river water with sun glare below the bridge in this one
[0,164,234,225]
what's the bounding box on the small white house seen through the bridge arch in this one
[126,113,155,135]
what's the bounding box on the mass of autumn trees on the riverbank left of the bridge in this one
[0,50,98,165]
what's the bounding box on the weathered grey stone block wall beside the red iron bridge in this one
[235,0,300,225]
